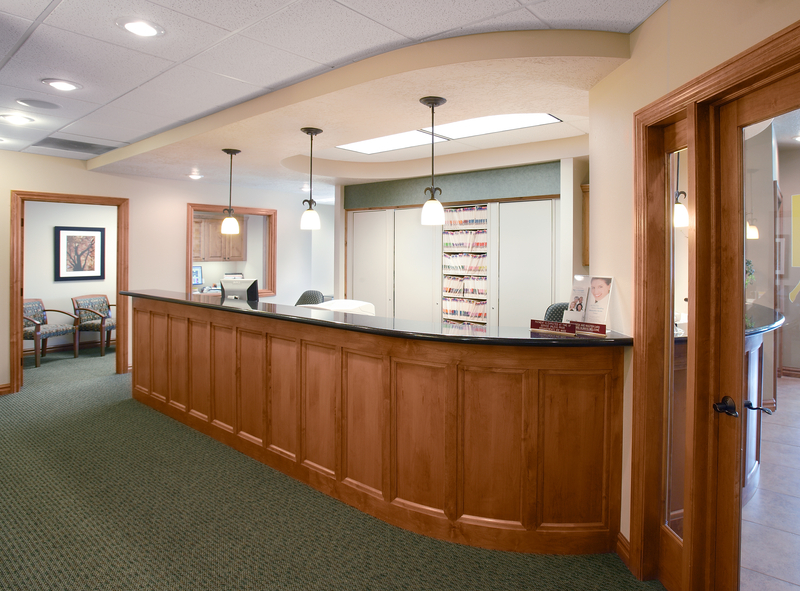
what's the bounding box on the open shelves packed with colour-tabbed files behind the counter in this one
[442,205,489,335]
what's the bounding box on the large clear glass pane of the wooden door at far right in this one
[740,112,800,590]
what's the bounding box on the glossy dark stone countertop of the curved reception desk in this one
[119,290,633,347]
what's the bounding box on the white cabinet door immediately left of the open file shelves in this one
[394,207,442,322]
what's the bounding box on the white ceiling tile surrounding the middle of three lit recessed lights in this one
[1,25,172,103]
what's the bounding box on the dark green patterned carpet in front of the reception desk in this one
[0,349,663,591]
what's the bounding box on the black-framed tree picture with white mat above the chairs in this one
[55,226,106,281]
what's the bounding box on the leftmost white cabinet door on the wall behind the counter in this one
[348,210,394,318]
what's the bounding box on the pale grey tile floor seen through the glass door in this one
[741,378,800,591]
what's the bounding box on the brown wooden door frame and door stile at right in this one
[629,22,800,591]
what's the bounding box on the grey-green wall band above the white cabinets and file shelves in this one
[344,161,561,209]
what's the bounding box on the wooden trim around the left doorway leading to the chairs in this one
[9,191,129,392]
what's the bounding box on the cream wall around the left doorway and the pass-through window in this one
[0,151,311,384]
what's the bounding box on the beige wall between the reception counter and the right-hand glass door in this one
[589,0,800,536]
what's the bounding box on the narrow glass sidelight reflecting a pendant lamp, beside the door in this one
[664,149,690,538]
